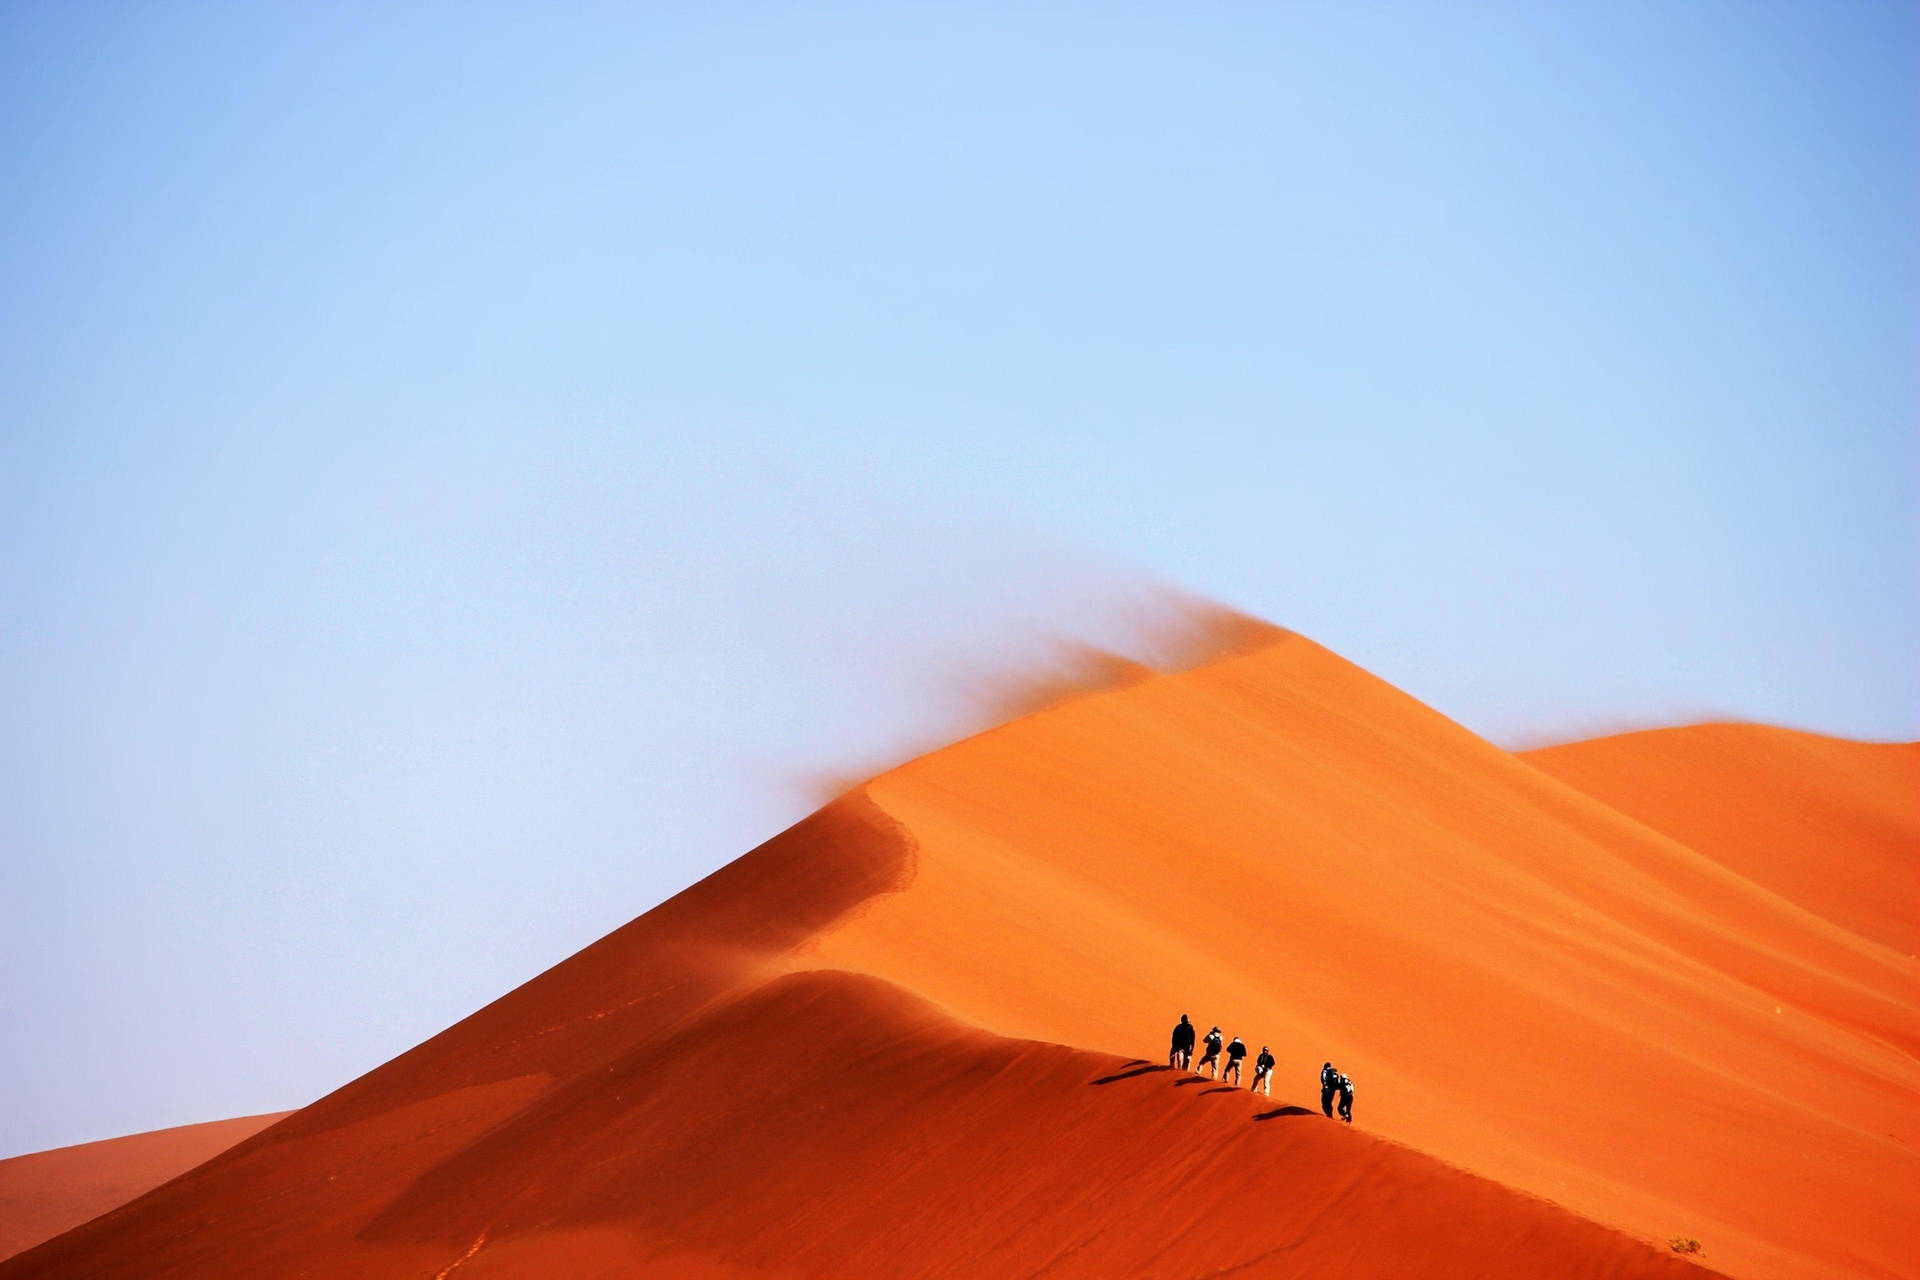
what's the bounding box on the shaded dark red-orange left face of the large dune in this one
[0,796,1711,1280]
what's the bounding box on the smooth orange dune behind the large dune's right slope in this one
[1524,723,1920,958]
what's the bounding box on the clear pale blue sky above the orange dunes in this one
[0,0,1920,1153]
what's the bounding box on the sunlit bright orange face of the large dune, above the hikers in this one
[814,637,1920,1276]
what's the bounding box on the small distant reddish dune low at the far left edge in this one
[0,1111,286,1259]
